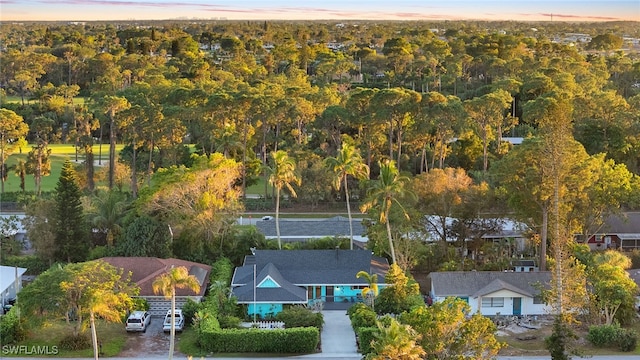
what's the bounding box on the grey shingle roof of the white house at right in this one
[429,271,551,298]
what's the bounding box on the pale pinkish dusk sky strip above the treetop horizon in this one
[0,0,640,21]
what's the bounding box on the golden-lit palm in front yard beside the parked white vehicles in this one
[152,266,200,360]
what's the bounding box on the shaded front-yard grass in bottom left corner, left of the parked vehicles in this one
[3,320,127,358]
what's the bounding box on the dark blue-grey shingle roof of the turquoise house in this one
[231,250,389,303]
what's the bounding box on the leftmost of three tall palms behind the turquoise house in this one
[267,150,302,249]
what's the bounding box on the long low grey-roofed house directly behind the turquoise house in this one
[256,216,367,248]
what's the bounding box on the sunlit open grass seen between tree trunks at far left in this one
[4,144,124,192]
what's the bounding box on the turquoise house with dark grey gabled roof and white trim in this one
[231,249,389,317]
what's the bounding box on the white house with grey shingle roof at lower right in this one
[429,271,551,316]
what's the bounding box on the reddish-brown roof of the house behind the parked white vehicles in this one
[100,257,211,296]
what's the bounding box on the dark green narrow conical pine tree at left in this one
[55,160,89,262]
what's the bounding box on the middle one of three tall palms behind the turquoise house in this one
[325,144,369,250]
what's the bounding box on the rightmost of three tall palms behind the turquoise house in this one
[360,160,415,264]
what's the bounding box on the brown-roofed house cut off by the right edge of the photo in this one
[585,212,640,251]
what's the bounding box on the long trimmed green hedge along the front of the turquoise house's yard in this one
[199,327,320,354]
